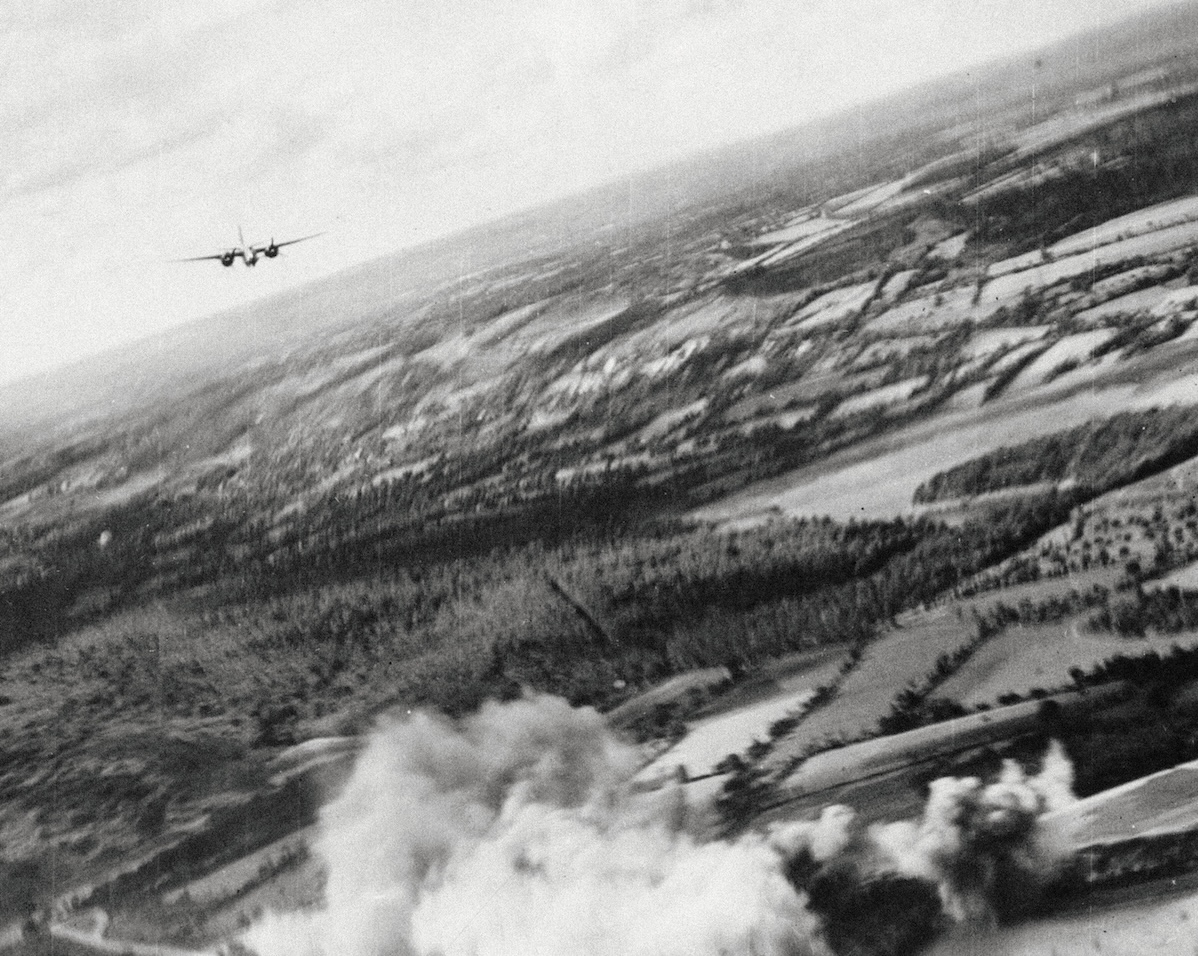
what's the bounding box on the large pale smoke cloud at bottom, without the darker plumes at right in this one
[244,697,825,956]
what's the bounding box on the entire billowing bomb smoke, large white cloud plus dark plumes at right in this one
[244,697,1067,956]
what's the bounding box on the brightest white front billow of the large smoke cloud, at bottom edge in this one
[412,806,823,956]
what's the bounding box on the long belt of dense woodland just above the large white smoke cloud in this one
[0,496,1069,743]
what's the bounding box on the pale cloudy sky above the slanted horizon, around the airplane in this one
[0,0,1178,382]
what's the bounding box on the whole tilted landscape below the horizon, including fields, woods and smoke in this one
[7,5,1198,956]
